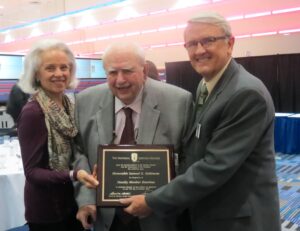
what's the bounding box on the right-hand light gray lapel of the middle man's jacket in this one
[137,78,160,144]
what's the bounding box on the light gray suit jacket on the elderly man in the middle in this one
[75,78,193,231]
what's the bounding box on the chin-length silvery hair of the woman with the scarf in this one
[18,39,79,94]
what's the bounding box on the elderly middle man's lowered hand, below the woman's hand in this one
[76,205,96,229]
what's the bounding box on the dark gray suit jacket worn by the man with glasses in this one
[146,60,280,231]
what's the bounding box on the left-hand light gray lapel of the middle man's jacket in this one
[96,89,115,144]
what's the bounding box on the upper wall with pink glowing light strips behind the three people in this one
[0,0,300,67]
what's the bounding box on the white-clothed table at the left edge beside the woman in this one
[0,170,26,231]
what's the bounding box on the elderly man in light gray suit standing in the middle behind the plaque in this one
[75,43,193,231]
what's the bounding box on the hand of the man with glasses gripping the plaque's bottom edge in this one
[120,195,152,218]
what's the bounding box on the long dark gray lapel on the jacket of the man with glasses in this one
[185,59,238,141]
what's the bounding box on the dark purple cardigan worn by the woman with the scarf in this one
[18,101,77,223]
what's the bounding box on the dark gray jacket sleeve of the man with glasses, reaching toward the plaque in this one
[146,89,273,216]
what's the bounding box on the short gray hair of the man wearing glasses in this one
[188,12,232,37]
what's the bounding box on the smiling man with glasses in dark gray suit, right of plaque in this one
[122,13,280,231]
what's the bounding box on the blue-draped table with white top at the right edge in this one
[274,113,300,154]
